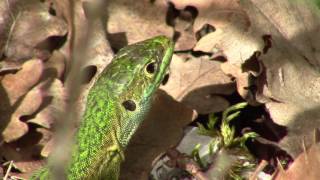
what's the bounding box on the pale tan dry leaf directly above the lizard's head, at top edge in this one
[107,0,173,48]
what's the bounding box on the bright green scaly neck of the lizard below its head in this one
[67,82,151,179]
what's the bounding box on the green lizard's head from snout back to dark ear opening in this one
[106,36,173,111]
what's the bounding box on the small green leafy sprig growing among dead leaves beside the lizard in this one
[192,102,258,179]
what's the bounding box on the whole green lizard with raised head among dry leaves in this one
[31,36,173,180]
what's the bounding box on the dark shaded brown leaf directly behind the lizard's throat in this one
[120,91,195,179]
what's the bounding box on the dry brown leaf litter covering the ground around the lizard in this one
[0,0,320,179]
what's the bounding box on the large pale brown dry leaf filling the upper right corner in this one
[181,0,320,156]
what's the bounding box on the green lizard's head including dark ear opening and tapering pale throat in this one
[102,36,174,146]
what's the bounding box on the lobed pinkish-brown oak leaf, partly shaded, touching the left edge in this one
[0,59,43,142]
